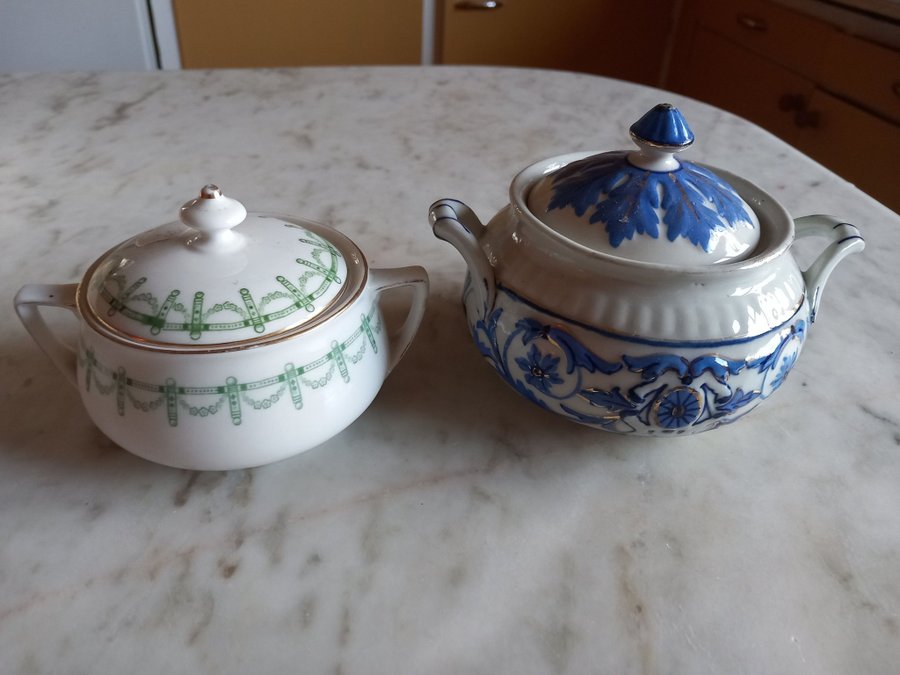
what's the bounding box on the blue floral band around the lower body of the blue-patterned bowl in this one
[471,294,806,434]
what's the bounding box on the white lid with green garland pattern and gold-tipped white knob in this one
[79,185,367,349]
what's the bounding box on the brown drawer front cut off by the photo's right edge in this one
[820,31,900,123]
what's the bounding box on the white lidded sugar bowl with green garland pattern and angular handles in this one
[15,185,428,470]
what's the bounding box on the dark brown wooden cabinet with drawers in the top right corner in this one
[665,0,900,211]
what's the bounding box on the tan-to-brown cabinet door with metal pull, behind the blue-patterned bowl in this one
[438,0,673,84]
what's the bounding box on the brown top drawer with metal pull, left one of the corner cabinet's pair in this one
[685,0,832,77]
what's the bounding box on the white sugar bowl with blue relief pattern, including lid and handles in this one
[430,104,865,435]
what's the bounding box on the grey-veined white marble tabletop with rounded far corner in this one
[0,68,900,674]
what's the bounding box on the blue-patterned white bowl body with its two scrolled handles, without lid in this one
[431,153,864,435]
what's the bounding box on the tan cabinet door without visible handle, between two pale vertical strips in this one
[172,0,422,68]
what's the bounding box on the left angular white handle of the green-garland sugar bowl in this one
[13,284,78,387]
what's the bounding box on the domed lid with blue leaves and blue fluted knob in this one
[527,103,760,266]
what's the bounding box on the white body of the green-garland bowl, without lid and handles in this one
[77,289,390,470]
